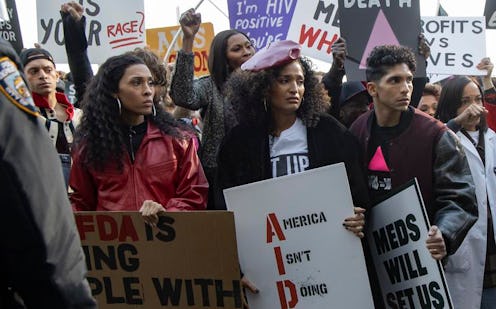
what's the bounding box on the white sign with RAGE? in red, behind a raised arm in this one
[36,0,145,63]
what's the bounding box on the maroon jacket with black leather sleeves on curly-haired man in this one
[350,107,477,254]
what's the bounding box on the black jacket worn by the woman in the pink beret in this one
[217,114,368,209]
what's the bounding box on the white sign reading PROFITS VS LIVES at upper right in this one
[421,16,486,75]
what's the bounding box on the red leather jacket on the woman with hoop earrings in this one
[69,123,208,211]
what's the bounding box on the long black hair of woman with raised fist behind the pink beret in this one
[208,29,250,91]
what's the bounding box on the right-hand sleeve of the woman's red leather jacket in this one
[164,139,208,211]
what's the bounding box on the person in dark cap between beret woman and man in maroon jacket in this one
[339,82,371,128]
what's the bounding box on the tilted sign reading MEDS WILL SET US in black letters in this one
[365,180,453,308]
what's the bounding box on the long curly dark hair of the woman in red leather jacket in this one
[74,54,185,170]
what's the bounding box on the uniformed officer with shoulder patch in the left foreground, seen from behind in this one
[0,39,97,309]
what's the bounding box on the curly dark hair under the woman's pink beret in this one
[225,57,329,129]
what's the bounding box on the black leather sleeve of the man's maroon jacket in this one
[432,130,478,255]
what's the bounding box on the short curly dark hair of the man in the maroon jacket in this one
[365,45,417,82]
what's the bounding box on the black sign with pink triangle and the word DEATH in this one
[339,0,425,81]
